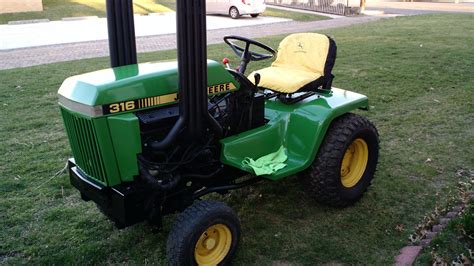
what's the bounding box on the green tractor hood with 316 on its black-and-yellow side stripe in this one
[58,60,239,117]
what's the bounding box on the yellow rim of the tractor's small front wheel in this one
[194,224,232,265]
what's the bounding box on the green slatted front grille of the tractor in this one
[61,108,107,185]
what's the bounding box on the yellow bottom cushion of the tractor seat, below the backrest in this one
[249,66,322,93]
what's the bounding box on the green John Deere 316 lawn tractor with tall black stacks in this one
[58,0,379,265]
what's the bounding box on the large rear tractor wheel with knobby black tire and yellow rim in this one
[301,113,379,207]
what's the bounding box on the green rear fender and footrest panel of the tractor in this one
[221,88,369,180]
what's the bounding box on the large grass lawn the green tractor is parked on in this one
[0,14,474,265]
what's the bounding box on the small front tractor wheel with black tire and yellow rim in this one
[166,200,240,265]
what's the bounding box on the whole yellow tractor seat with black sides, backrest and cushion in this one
[249,33,337,94]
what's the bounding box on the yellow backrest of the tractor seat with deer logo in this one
[272,33,336,76]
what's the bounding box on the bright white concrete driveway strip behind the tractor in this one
[0,12,291,50]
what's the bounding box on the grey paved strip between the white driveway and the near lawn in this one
[0,16,383,69]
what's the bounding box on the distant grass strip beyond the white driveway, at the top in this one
[0,0,329,24]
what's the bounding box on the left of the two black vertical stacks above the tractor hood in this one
[106,0,137,67]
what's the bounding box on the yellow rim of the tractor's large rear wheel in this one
[341,138,369,188]
